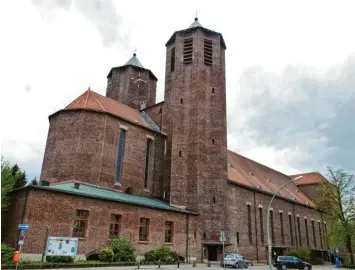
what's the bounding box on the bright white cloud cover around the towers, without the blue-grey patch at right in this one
[0,0,355,179]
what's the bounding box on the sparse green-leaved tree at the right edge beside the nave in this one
[315,167,355,264]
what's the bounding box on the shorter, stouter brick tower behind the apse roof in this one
[106,53,158,110]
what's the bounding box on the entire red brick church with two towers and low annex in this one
[3,18,328,261]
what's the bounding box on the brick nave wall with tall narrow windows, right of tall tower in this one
[226,184,324,260]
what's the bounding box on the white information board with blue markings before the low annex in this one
[46,236,78,256]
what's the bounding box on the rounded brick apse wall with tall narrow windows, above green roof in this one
[41,111,165,195]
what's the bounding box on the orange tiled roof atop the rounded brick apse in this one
[64,90,160,132]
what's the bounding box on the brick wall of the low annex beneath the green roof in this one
[6,190,196,257]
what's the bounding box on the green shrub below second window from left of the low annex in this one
[108,238,136,262]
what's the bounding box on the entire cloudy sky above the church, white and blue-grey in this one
[0,0,355,180]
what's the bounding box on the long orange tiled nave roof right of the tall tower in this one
[228,151,314,206]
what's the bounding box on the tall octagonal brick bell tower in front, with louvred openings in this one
[163,18,228,245]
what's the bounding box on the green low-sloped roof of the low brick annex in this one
[39,181,196,214]
